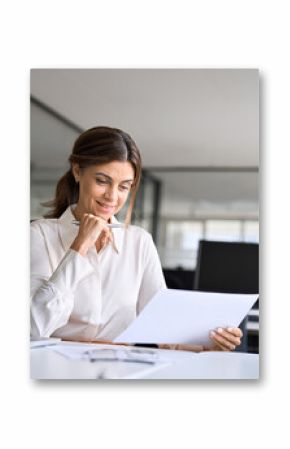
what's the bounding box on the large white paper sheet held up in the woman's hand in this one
[115,289,259,345]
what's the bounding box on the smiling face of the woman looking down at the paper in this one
[72,161,134,220]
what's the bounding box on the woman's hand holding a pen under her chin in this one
[71,214,111,256]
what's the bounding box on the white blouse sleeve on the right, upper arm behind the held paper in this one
[137,234,166,314]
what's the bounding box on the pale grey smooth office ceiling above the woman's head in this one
[31,69,259,167]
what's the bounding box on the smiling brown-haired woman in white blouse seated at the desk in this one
[31,127,242,350]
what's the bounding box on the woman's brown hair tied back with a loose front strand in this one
[43,126,141,224]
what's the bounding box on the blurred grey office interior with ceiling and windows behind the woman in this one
[31,69,259,352]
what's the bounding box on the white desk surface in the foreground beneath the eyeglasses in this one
[30,342,259,379]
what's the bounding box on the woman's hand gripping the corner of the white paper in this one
[206,327,243,351]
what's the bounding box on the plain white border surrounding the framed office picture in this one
[0,0,290,449]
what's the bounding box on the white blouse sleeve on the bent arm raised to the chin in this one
[30,223,93,337]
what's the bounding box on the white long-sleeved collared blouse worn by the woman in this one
[30,206,166,340]
